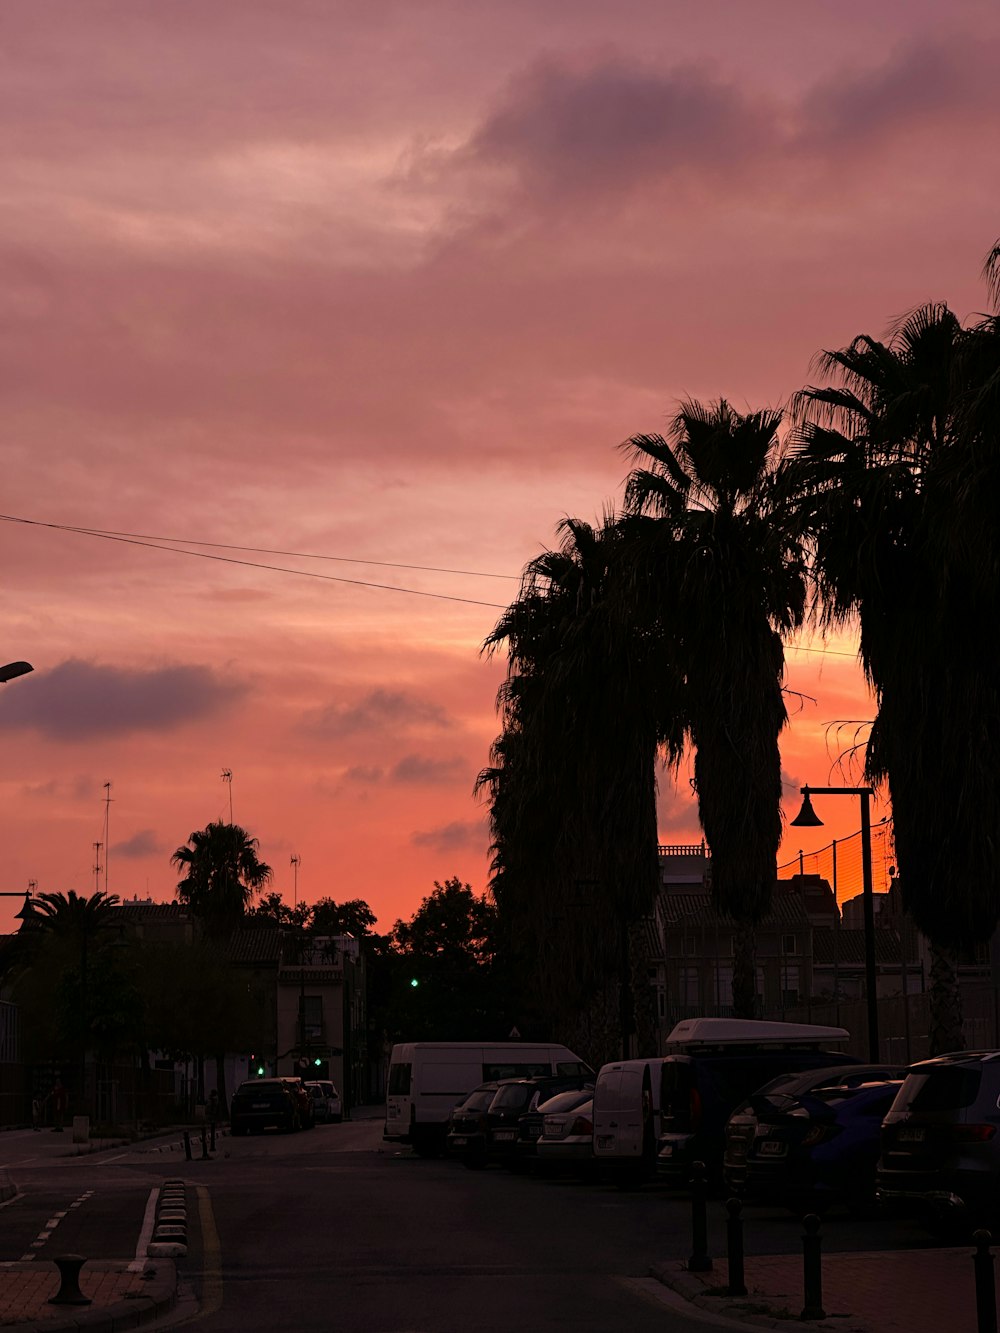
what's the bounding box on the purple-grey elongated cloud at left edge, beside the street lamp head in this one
[0,659,245,741]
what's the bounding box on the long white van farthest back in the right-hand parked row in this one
[383,1041,593,1157]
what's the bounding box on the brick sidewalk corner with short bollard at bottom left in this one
[0,1258,177,1333]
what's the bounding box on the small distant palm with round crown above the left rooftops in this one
[171,822,273,937]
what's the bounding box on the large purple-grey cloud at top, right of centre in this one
[455,55,773,200]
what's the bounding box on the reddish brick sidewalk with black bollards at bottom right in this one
[652,1244,992,1333]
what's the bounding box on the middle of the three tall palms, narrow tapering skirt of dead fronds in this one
[625,399,805,1017]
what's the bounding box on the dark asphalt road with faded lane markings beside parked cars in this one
[0,1120,928,1333]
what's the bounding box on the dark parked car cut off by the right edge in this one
[876,1050,1000,1230]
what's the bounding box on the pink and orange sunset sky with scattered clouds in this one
[0,0,1000,929]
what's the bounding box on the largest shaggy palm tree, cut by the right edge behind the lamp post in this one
[789,278,1000,1053]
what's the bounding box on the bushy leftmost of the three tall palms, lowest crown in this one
[477,515,671,1058]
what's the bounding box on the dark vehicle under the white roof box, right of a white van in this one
[656,1045,860,1185]
